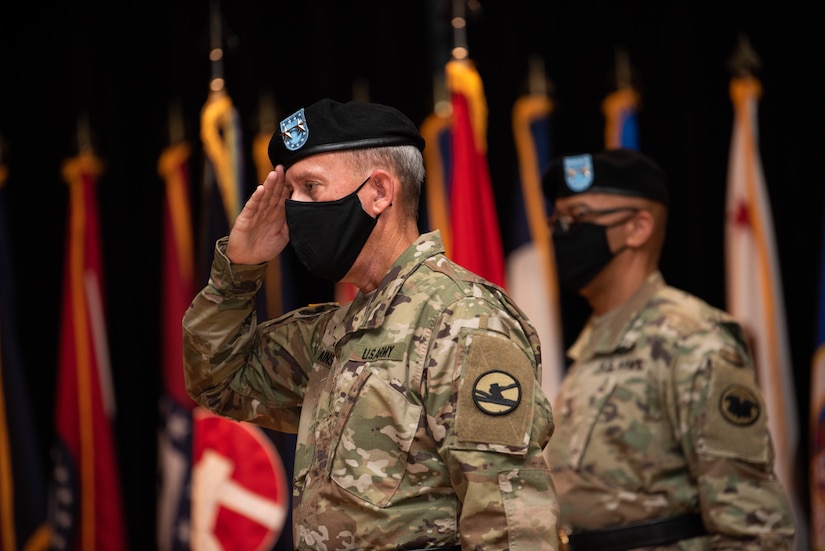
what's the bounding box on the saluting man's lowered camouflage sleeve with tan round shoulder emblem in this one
[425,300,558,551]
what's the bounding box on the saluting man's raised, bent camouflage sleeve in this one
[183,238,334,433]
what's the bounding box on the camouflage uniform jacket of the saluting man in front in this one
[183,232,558,551]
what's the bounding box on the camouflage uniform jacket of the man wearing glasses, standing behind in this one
[546,272,794,551]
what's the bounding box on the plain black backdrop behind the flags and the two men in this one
[0,0,825,549]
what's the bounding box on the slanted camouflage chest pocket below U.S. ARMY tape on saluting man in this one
[330,369,422,507]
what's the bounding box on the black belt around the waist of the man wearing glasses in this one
[567,513,708,551]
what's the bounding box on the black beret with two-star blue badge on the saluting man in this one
[269,99,424,169]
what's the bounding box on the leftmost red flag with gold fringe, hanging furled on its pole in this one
[52,152,127,551]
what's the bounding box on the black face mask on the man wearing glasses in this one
[553,222,624,293]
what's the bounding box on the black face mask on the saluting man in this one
[286,178,378,281]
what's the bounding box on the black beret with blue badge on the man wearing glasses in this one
[542,149,669,205]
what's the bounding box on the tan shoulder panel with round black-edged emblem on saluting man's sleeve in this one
[456,331,535,448]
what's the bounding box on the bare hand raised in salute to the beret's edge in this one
[226,165,289,264]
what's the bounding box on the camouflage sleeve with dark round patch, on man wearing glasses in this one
[680,331,794,551]
